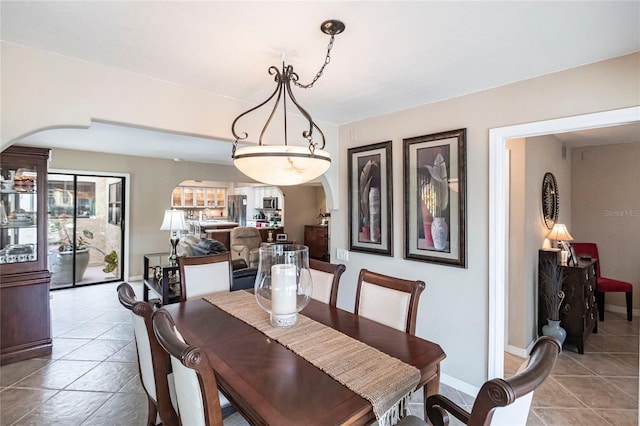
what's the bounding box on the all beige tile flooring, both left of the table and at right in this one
[0,283,640,426]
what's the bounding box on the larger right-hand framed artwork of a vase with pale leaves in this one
[403,129,467,268]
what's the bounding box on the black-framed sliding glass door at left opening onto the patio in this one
[47,173,125,290]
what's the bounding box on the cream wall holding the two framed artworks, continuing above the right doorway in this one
[338,55,640,386]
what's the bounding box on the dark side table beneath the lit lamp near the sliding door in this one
[142,253,180,305]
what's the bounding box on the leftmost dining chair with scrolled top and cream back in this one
[117,283,179,425]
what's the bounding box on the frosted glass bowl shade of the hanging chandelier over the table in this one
[233,145,331,186]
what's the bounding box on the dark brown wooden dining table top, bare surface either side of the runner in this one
[164,299,446,426]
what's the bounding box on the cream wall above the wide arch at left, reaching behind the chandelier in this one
[0,41,340,208]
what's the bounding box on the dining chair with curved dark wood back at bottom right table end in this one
[397,336,562,426]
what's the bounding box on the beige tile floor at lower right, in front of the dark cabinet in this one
[524,312,640,426]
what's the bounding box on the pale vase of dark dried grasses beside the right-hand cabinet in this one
[540,260,569,344]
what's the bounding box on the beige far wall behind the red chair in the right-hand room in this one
[570,143,640,312]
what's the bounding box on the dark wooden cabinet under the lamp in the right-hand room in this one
[538,250,598,354]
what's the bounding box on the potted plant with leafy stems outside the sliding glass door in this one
[49,215,118,284]
